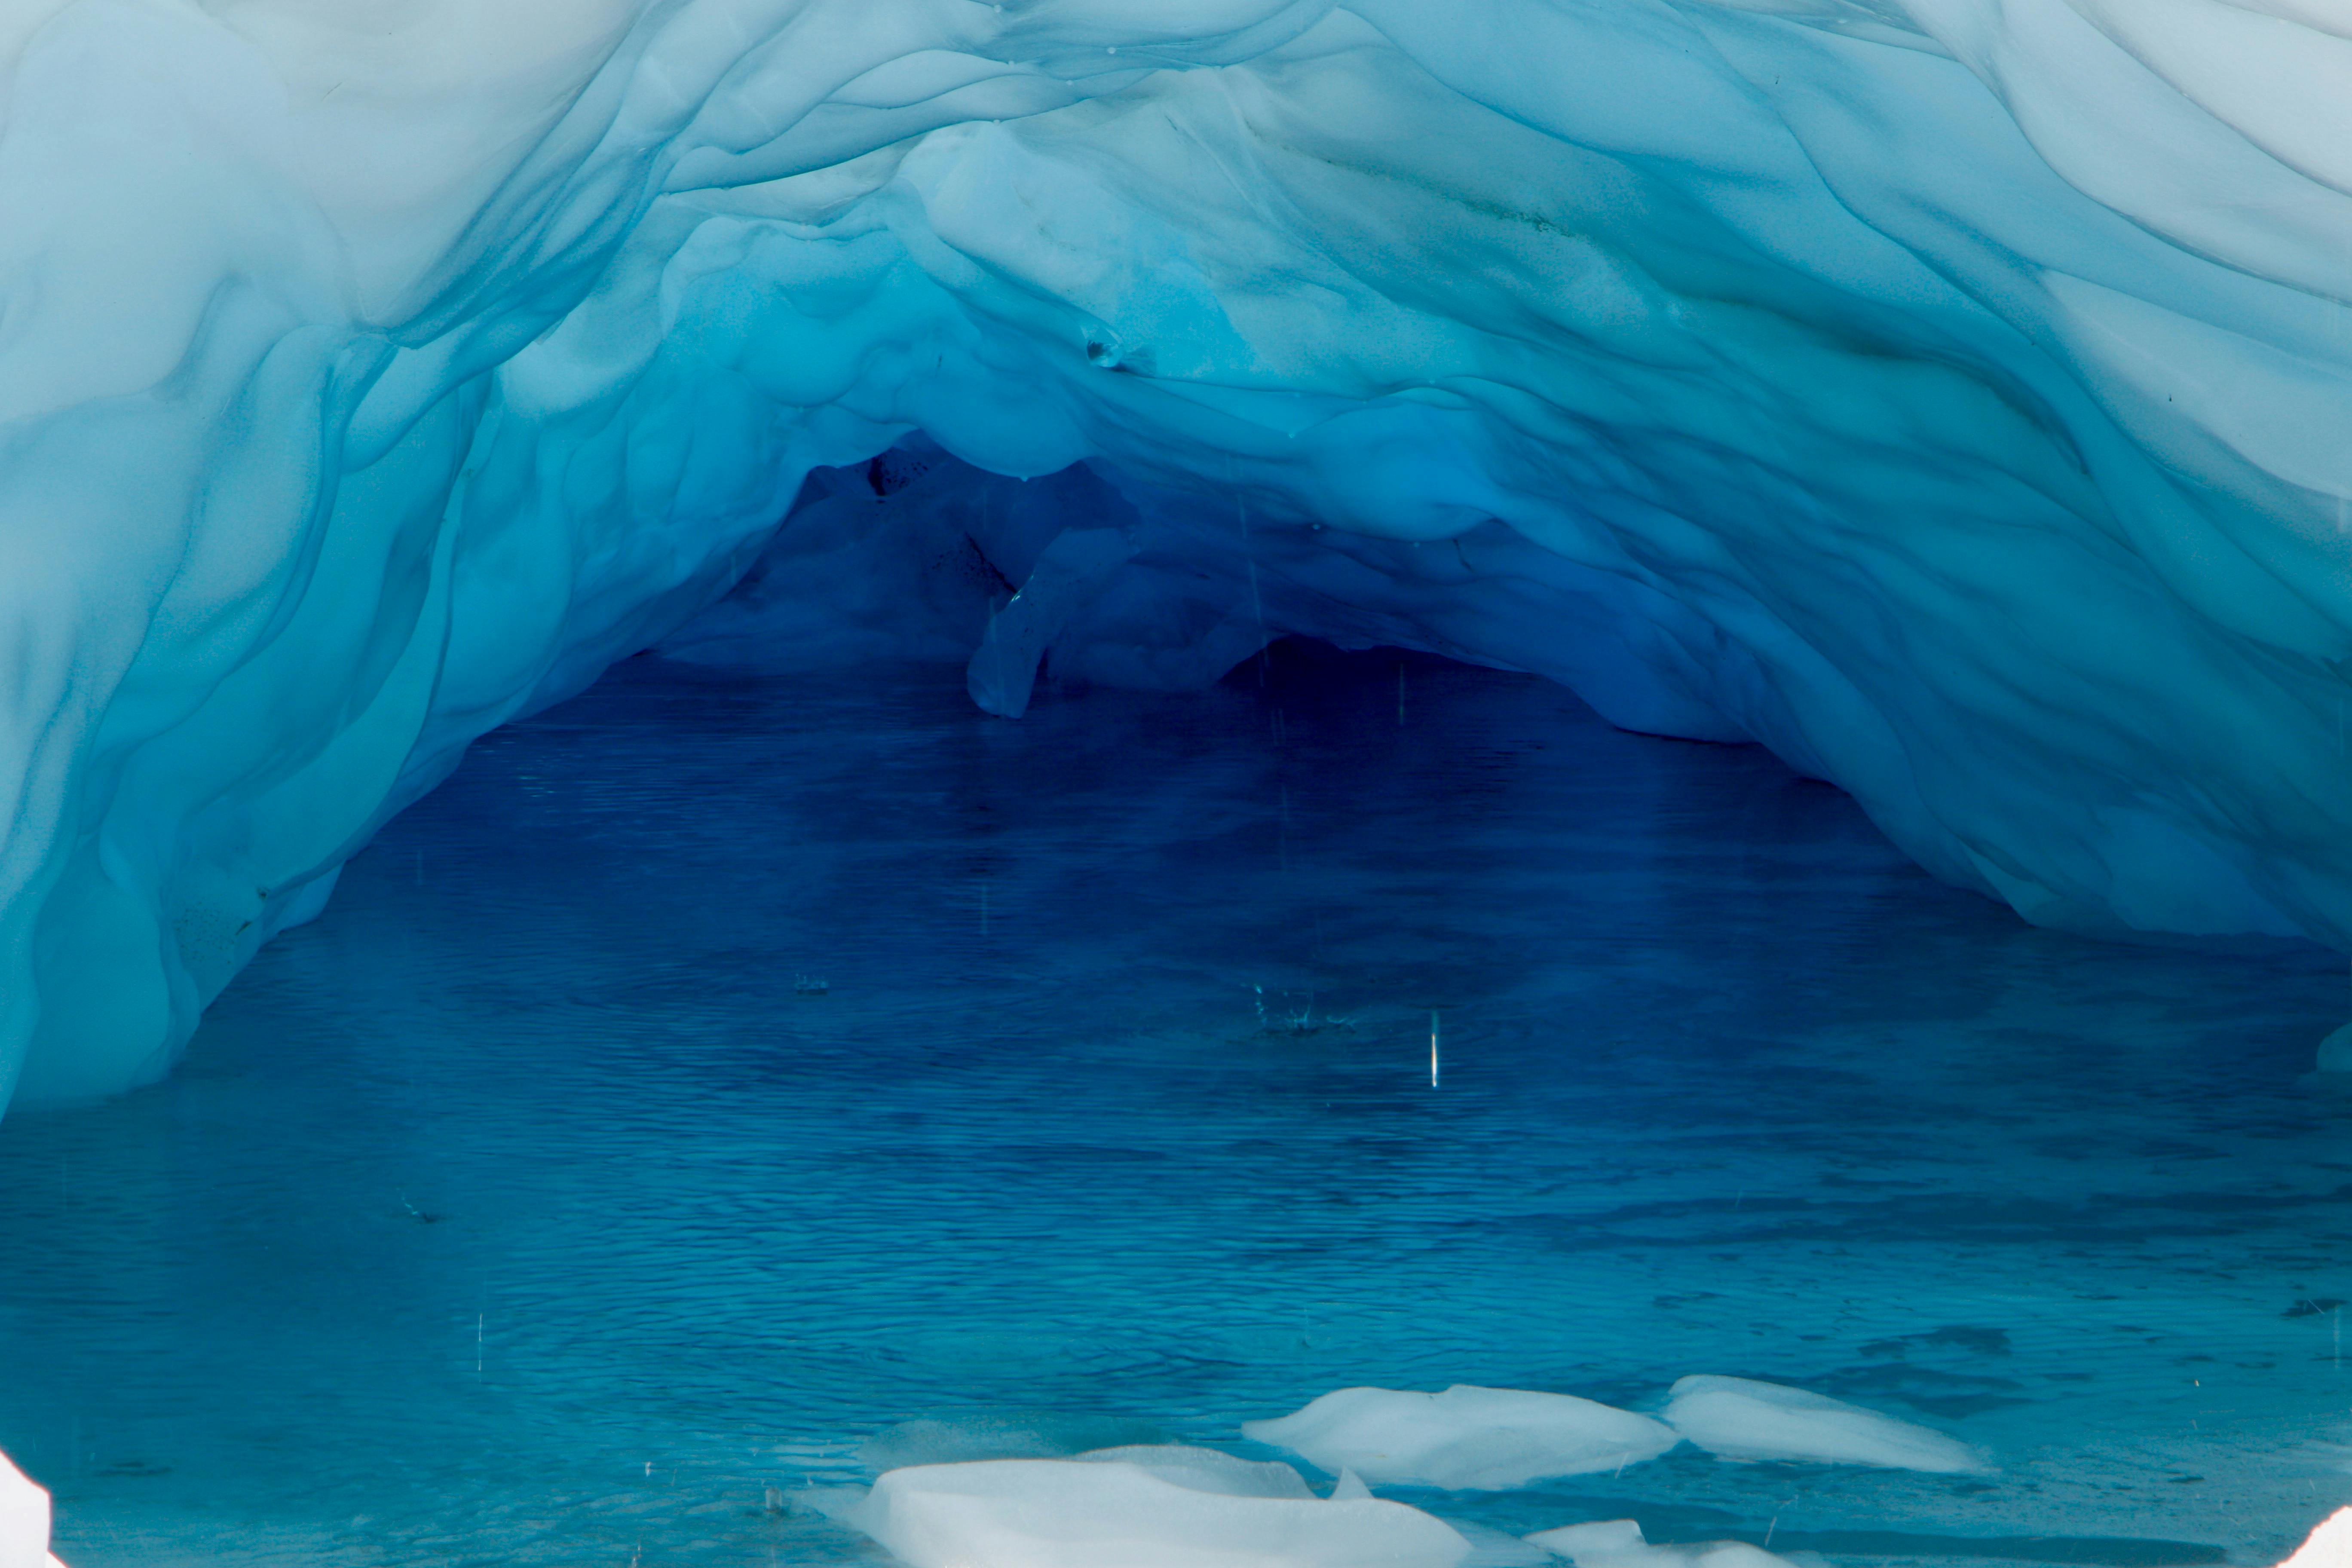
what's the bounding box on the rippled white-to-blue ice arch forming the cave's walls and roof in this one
[0,0,2352,1100]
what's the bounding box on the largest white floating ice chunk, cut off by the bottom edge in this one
[837,1448,1470,1568]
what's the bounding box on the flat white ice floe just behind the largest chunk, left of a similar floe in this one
[1242,1384,1679,1493]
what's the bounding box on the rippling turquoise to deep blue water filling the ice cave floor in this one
[0,649,2352,1568]
